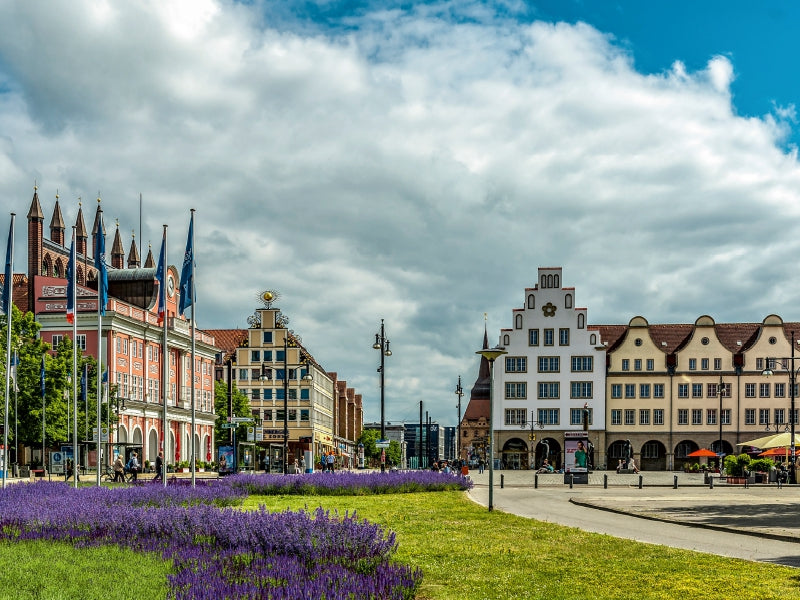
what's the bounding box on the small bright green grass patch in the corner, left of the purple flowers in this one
[0,541,171,600]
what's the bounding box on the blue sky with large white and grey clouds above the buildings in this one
[0,0,800,426]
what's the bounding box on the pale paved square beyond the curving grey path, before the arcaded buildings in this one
[470,471,800,542]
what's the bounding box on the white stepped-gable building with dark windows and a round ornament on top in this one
[493,267,606,469]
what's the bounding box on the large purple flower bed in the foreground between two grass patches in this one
[0,477,422,600]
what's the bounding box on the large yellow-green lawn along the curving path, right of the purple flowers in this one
[245,492,800,600]
